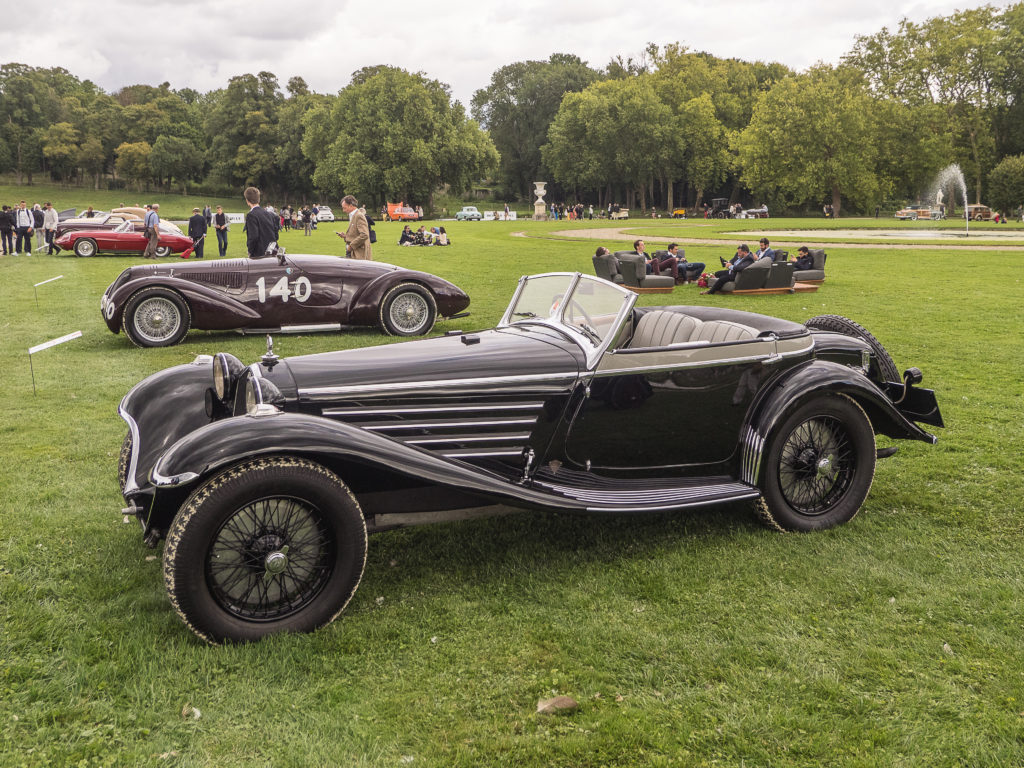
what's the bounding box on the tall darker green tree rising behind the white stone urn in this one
[472,53,601,199]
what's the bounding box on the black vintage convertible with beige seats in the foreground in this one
[119,273,942,642]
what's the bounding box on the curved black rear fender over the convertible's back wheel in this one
[740,359,936,485]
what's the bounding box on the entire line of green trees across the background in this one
[6,3,1024,212]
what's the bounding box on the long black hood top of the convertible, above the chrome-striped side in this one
[263,326,584,399]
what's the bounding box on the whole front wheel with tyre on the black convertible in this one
[164,457,367,643]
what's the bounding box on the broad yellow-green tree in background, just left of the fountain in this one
[734,66,878,216]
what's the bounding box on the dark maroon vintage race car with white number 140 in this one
[100,251,469,347]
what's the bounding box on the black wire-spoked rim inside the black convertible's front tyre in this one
[206,497,337,622]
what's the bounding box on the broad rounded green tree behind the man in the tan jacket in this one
[302,67,498,206]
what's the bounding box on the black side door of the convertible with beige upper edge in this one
[565,338,776,476]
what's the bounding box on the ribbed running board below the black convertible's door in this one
[534,470,761,512]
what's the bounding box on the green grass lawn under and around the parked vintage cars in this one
[0,215,1024,768]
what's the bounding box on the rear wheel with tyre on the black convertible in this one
[761,394,874,530]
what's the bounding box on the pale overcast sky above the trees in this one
[0,0,1010,108]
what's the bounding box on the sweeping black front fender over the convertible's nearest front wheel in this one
[151,413,585,518]
